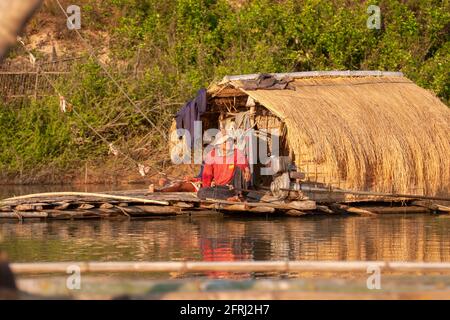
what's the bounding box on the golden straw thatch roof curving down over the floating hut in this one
[209,71,450,195]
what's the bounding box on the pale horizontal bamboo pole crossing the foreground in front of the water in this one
[10,261,450,274]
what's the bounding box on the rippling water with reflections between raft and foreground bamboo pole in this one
[0,215,450,262]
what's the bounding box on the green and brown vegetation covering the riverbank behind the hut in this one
[0,0,450,183]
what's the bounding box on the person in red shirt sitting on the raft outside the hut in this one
[197,135,251,201]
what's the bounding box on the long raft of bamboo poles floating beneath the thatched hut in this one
[0,190,450,221]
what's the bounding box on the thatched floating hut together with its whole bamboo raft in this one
[0,71,450,220]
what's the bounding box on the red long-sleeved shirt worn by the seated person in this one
[202,149,248,187]
